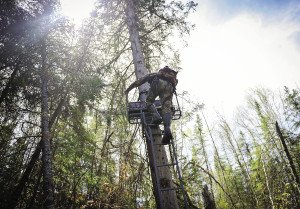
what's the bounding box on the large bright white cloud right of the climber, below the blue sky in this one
[178,5,300,114]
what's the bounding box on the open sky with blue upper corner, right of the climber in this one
[178,0,300,116]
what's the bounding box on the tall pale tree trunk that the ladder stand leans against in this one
[125,0,179,209]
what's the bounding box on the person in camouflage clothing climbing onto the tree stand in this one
[125,66,178,145]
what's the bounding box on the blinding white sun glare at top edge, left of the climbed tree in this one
[60,0,96,25]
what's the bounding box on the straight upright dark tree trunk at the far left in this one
[41,42,54,209]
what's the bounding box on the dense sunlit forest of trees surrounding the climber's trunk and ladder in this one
[0,0,300,209]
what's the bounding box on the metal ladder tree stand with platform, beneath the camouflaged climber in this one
[127,96,188,209]
